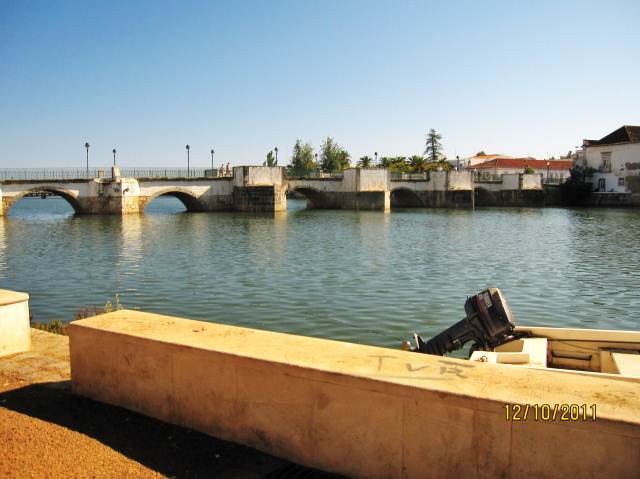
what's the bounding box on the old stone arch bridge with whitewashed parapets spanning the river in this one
[0,166,537,215]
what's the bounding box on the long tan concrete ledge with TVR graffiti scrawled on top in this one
[69,310,640,478]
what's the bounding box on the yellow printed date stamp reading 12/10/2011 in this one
[504,404,597,422]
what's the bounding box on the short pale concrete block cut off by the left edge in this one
[0,289,31,356]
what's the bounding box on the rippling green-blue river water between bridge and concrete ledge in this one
[0,197,640,347]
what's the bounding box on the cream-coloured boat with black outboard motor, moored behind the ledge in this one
[402,288,640,382]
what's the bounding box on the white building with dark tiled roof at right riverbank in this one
[578,125,640,193]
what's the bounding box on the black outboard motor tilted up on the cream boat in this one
[403,288,528,356]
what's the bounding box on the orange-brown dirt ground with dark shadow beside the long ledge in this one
[0,332,337,479]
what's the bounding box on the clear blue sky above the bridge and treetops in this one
[0,0,640,167]
